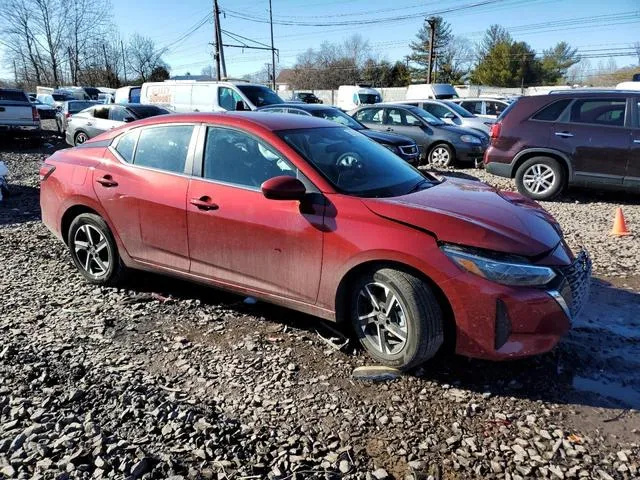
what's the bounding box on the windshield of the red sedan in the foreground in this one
[278,127,435,197]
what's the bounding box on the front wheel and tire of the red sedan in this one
[350,268,444,370]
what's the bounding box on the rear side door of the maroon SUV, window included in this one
[550,97,632,185]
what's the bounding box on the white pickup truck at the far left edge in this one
[0,88,41,137]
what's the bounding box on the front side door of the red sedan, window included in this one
[187,127,324,303]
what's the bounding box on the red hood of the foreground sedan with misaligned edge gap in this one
[363,178,561,257]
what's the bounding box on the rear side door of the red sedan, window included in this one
[94,125,195,271]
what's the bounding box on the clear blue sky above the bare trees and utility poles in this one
[4,0,640,81]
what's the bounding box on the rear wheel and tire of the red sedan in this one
[67,213,127,286]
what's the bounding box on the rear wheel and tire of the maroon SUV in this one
[516,157,566,200]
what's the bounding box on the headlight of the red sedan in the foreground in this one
[442,246,556,287]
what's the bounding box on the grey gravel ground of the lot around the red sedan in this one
[0,122,640,480]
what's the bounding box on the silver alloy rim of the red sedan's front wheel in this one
[356,282,408,355]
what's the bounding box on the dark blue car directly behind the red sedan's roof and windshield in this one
[258,103,420,166]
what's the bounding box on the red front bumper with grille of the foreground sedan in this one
[444,253,591,360]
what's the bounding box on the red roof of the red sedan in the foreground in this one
[101,112,338,132]
